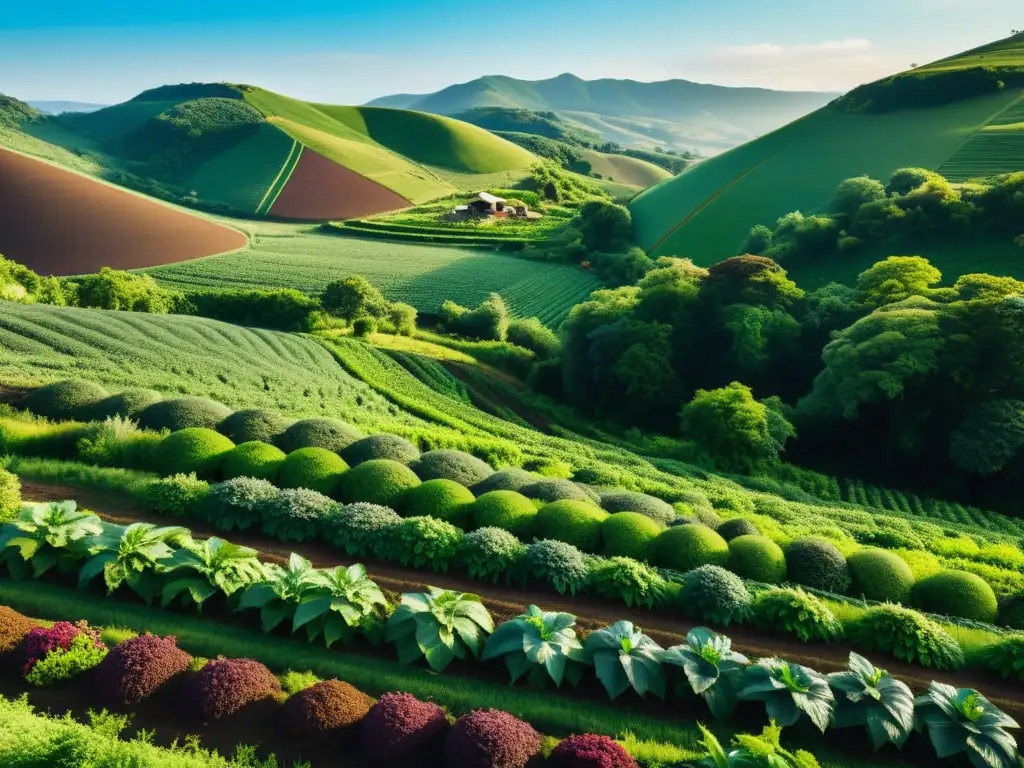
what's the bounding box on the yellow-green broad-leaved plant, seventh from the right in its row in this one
[387,587,495,672]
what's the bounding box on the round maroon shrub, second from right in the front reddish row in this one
[444,710,541,768]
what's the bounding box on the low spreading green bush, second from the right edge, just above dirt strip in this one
[846,605,964,670]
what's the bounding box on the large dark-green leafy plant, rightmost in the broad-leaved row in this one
[914,680,1020,768]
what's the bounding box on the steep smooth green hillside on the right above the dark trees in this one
[631,36,1024,264]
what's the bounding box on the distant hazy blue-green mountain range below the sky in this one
[369,74,839,154]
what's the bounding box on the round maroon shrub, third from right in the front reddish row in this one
[359,693,449,762]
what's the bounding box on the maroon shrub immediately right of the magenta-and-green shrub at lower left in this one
[96,635,191,707]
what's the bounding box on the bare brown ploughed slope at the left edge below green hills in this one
[0,148,249,275]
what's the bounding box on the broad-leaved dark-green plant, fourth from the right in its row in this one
[662,627,750,720]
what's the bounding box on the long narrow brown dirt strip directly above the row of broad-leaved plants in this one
[23,481,1024,721]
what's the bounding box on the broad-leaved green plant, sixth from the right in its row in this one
[482,605,588,686]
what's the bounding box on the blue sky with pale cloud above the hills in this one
[0,0,1024,103]
